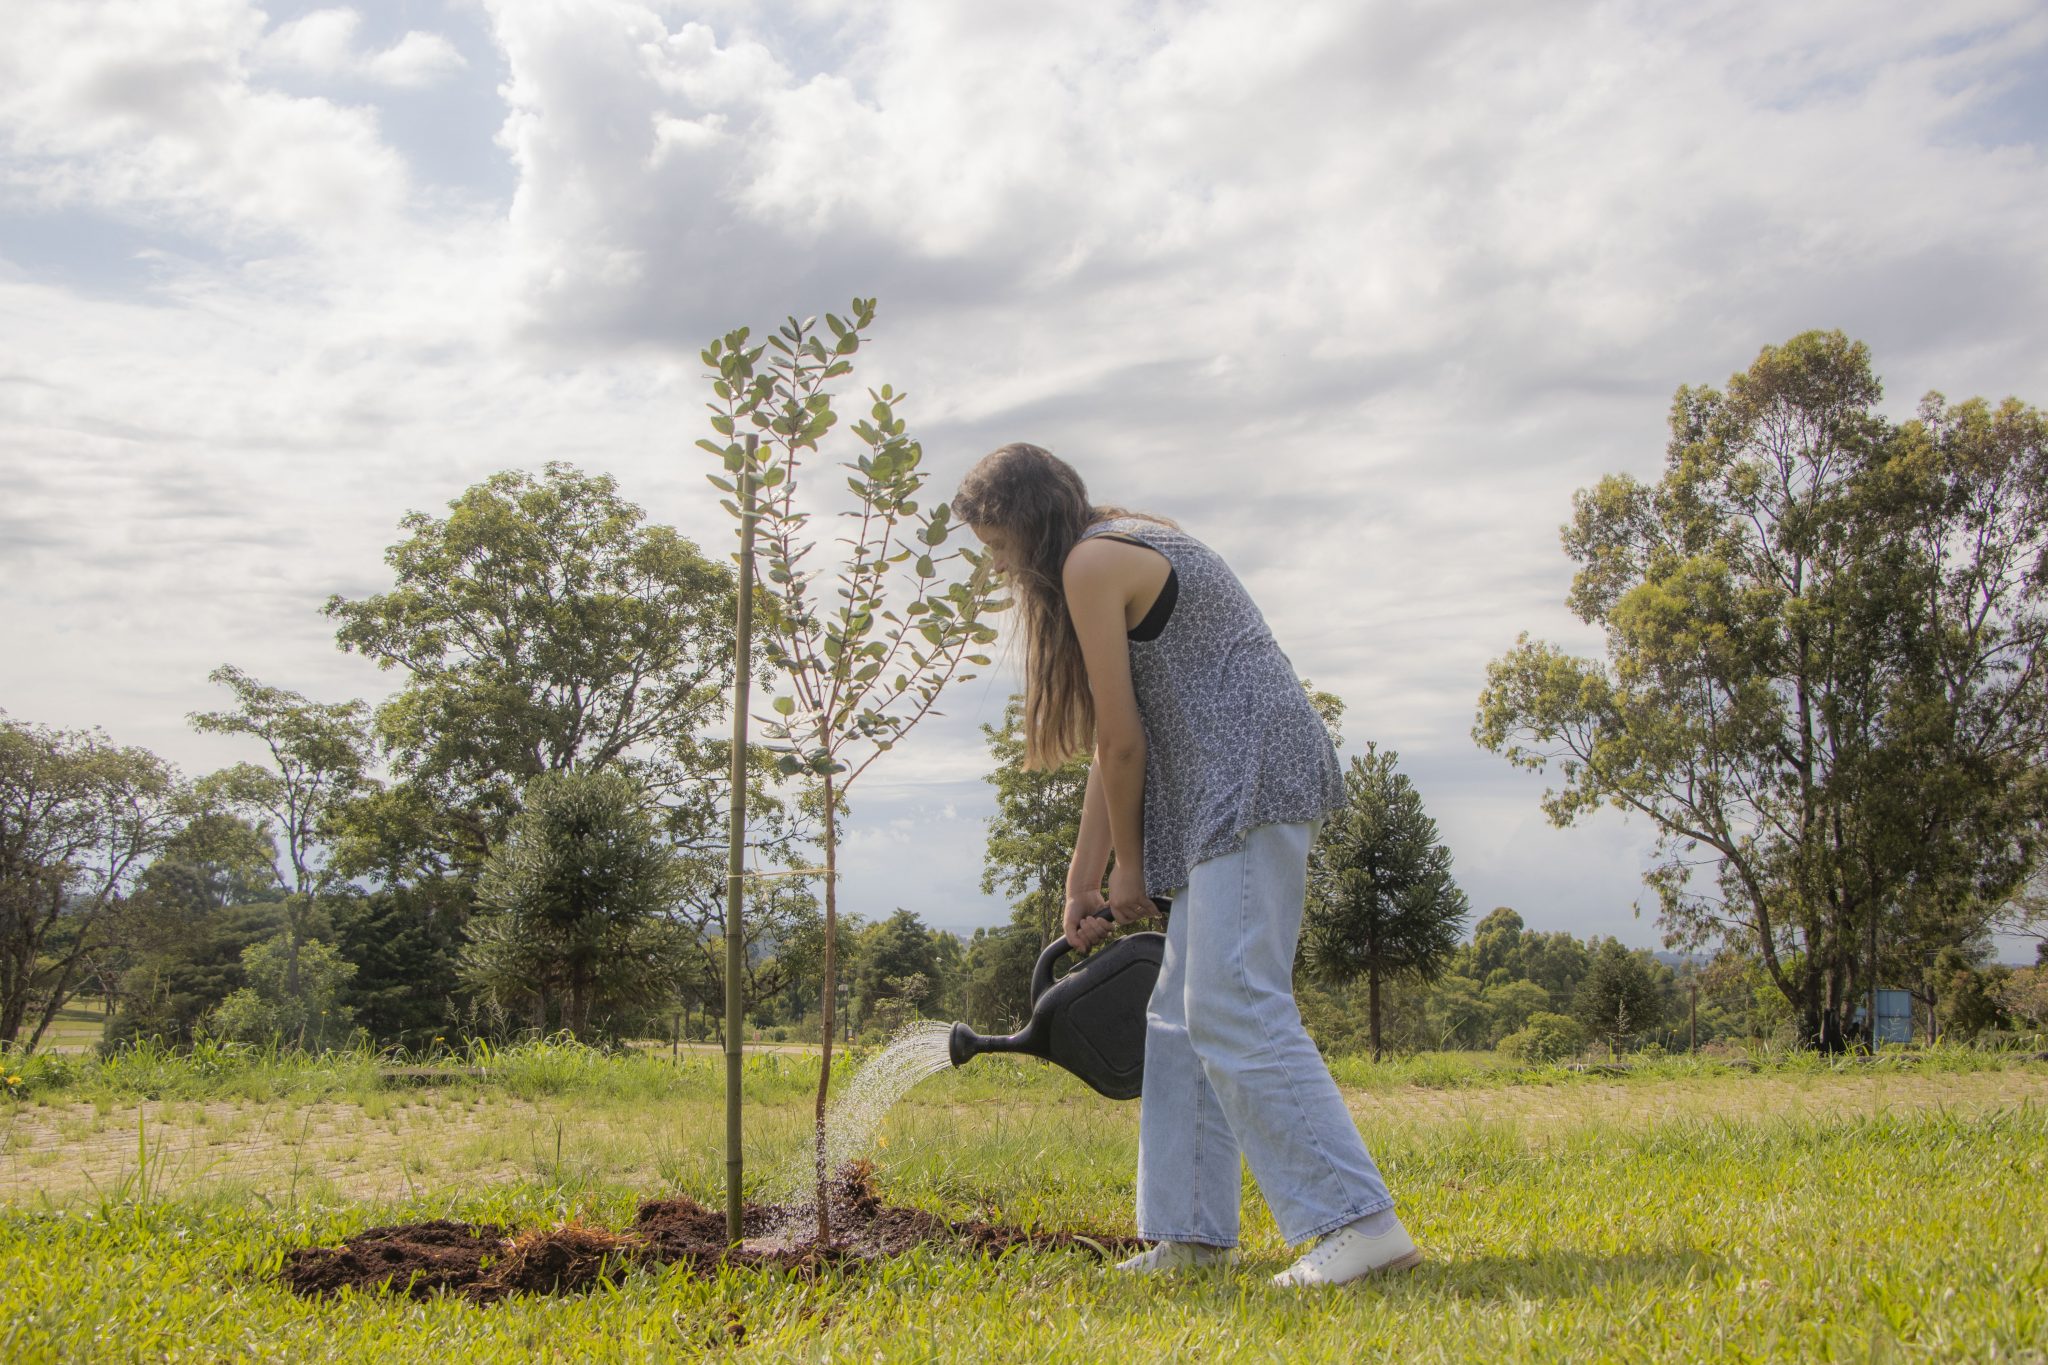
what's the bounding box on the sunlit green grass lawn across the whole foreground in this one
[0,1048,2048,1363]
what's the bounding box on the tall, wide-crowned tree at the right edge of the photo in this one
[1473,332,2048,1048]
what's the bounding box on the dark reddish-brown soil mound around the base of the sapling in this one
[279,1162,1141,1304]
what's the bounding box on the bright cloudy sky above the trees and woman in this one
[0,0,2048,956]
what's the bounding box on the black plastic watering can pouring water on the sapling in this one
[950,898,1167,1099]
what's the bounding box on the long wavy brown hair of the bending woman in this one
[952,442,1174,769]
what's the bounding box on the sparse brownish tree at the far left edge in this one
[0,718,190,1052]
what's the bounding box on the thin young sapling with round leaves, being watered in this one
[698,299,1008,1242]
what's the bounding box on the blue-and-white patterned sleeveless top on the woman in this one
[1081,518,1343,896]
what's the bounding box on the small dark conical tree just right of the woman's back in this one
[1303,745,1468,1058]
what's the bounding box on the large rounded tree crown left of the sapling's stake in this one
[326,463,749,880]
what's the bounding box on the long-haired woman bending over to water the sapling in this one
[952,444,1421,1285]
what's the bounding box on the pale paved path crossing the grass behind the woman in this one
[0,1066,2048,1207]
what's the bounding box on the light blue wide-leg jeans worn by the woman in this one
[1139,825,1393,1246]
